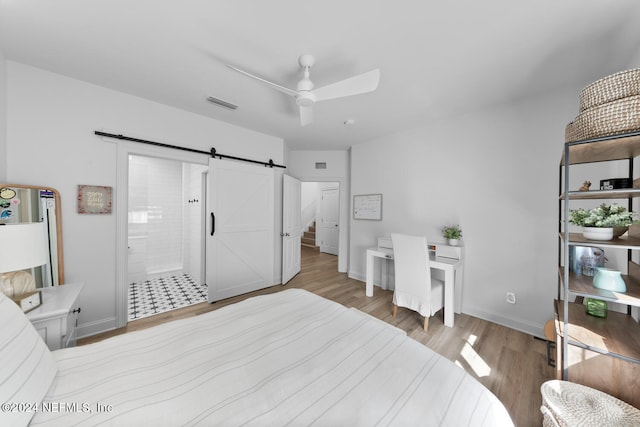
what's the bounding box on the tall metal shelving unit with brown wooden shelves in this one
[555,132,640,380]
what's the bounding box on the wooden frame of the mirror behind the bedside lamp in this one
[0,184,64,286]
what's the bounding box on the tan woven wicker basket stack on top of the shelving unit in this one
[565,69,640,142]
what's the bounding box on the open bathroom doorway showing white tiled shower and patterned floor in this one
[127,155,207,321]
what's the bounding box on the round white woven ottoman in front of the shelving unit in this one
[540,380,640,427]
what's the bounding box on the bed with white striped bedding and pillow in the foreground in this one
[0,289,513,427]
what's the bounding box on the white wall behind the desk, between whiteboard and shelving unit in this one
[349,91,577,336]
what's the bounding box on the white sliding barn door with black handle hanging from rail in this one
[206,159,275,302]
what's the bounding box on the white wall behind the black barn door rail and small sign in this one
[7,61,284,335]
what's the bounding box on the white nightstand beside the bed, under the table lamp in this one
[27,283,84,350]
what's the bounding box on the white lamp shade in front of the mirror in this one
[0,222,49,273]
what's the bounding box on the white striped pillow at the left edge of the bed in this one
[0,292,58,426]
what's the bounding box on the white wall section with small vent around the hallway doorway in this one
[286,150,351,273]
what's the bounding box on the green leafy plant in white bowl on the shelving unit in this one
[569,203,637,240]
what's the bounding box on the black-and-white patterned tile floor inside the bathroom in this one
[128,274,207,321]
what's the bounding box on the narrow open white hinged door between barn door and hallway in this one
[282,175,302,285]
